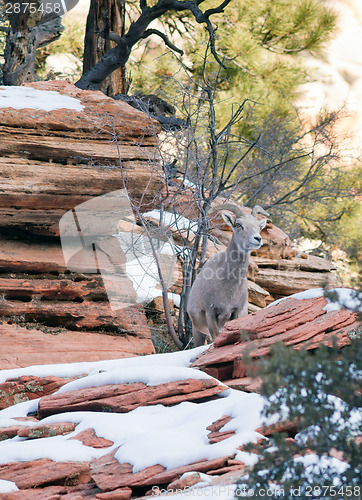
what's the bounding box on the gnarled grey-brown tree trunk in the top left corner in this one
[3,0,64,85]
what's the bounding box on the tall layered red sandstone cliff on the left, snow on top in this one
[0,81,162,368]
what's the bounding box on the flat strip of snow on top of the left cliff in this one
[0,86,84,111]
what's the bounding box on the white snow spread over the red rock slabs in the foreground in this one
[0,346,269,472]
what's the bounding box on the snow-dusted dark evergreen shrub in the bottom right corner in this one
[239,332,362,499]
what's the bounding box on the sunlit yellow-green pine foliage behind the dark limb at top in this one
[130,0,336,129]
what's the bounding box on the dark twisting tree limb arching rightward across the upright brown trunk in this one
[76,0,231,90]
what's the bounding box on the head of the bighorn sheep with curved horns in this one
[212,203,269,251]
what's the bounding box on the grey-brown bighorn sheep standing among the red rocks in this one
[187,203,269,346]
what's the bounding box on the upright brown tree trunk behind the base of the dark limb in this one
[83,0,126,96]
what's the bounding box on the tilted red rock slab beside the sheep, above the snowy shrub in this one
[193,297,361,392]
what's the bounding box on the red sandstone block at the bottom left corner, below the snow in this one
[0,458,90,489]
